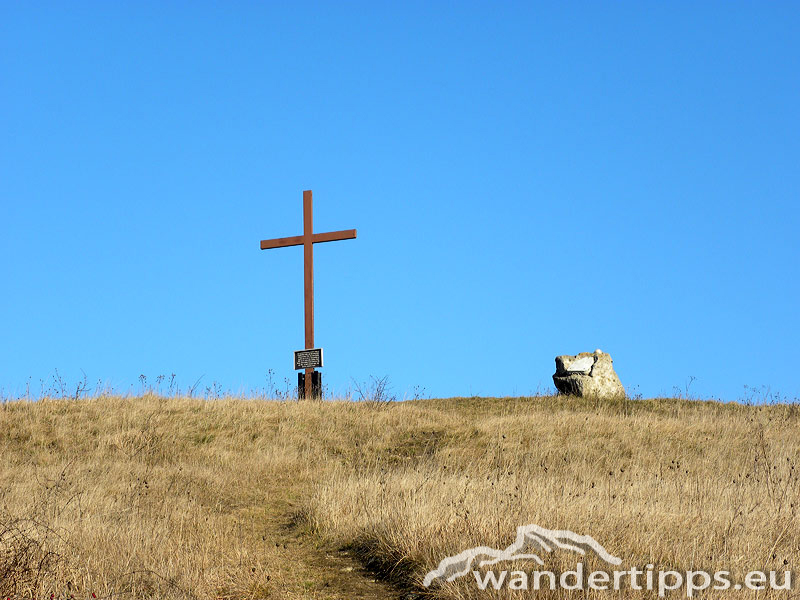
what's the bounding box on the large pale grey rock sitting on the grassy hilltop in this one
[553,350,625,398]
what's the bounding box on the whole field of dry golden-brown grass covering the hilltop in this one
[0,395,800,599]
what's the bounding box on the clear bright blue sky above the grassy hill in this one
[0,0,800,400]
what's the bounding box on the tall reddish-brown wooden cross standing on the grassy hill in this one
[261,190,356,398]
